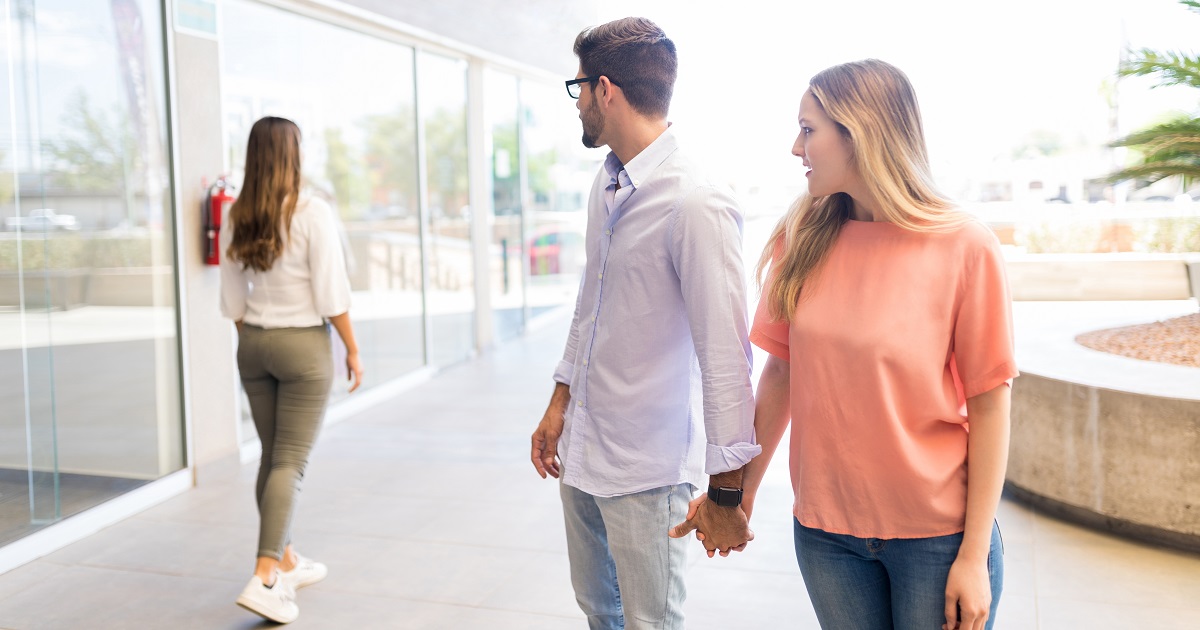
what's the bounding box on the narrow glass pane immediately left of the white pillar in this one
[418,53,475,366]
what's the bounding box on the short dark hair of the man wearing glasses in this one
[575,18,678,118]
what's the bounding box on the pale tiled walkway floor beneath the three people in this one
[0,312,1200,630]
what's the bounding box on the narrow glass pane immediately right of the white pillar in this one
[484,72,524,341]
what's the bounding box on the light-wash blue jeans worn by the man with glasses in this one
[559,484,692,630]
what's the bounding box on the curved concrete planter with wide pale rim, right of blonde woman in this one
[1007,300,1200,551]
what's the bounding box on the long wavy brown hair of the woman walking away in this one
[226,116,300,271]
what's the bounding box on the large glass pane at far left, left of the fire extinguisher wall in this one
[0,0,185,545]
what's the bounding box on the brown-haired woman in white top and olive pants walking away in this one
[221,116,362,623]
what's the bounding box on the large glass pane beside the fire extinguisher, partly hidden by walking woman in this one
[221,1,425,417]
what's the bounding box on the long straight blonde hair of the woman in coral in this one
[757,59,970,322]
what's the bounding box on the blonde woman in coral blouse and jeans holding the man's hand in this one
[743,60,1018,630]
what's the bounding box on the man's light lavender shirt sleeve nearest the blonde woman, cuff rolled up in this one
[670,186,762,475]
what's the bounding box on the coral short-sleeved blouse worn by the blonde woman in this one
[750,221,1018,539]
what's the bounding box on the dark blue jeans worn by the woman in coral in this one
[793,518,1004,630]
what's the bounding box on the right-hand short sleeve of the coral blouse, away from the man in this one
[954,226,1019,398]
